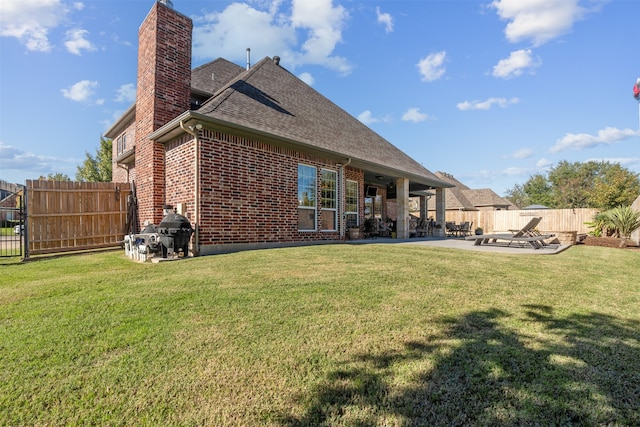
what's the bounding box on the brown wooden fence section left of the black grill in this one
[26,180,131,255]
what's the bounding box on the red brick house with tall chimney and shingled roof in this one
[105,0,451,254]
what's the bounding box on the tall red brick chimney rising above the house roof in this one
[135,0,193,224]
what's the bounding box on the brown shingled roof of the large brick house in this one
[150,58,450,190]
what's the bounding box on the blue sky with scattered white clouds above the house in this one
[0,0,640,195]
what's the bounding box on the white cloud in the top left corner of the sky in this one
[0,0,67,52]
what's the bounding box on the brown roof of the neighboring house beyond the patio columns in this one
[435,172,515,210]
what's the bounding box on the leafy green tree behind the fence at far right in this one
[507,161,640,210]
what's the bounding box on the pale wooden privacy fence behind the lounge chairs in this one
[438,208,599,234]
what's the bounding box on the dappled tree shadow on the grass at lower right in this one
[281,306,640,426]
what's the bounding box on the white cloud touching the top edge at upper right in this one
[491,0,587,46]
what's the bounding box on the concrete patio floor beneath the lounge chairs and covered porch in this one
[347,237,571,255]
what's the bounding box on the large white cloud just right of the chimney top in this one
[193,0,352,75]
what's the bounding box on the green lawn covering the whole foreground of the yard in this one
[0,244,640,426]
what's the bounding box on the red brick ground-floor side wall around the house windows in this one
[166,129,364,246]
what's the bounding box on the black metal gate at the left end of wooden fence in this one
[0,193,26,258]
